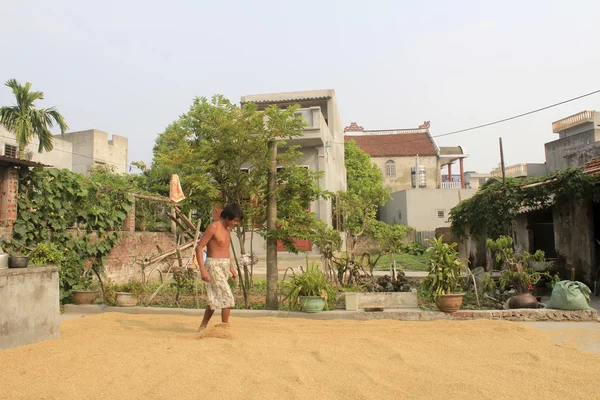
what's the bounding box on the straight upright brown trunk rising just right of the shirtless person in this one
[267,140,279,310]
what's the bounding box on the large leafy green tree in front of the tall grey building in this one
[153,95,325,305]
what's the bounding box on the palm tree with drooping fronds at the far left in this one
[0,79,69,158]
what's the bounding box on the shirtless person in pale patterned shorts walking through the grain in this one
[196,203,244,331]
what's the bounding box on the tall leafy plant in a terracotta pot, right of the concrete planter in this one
[423,236,465,313]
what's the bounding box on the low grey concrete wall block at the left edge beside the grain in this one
[0,267,60,349]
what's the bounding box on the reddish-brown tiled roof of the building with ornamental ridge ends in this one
[344,133,437,157]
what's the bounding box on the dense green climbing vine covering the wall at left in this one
[3,168,133,301]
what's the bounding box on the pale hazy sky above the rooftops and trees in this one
[0,0,600,172]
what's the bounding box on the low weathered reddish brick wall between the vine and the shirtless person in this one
[104,232,192,282]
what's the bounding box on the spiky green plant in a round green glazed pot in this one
[284,260,335,313]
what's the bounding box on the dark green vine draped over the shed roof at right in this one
[450,168,598,239]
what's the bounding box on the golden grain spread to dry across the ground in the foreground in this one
[0,313,600,400]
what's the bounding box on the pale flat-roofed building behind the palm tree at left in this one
[0,125,129,174]
